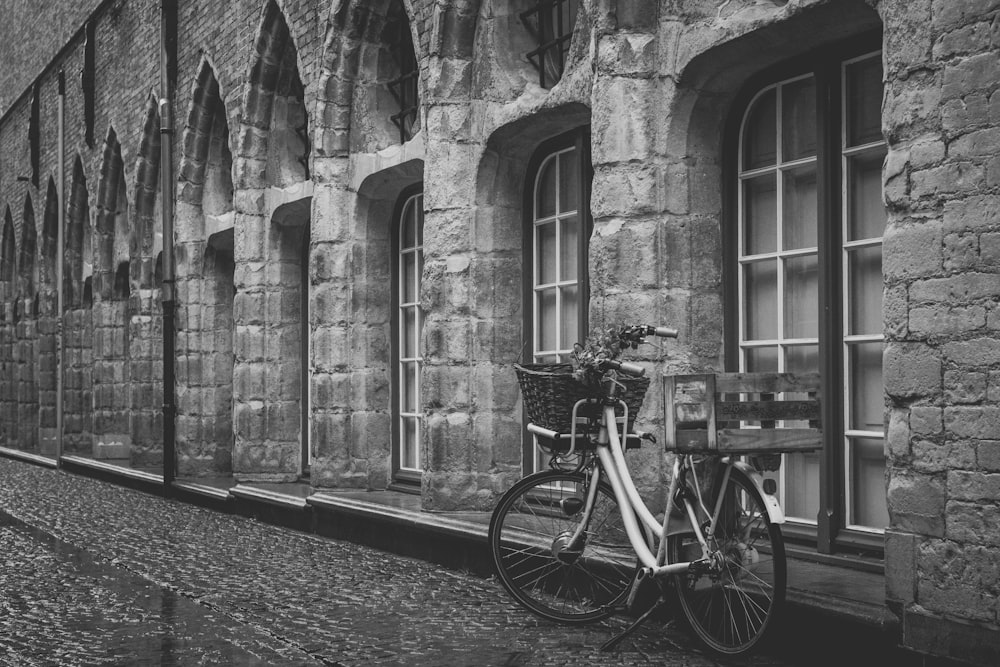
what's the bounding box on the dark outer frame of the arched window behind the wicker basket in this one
[521,125,594,473]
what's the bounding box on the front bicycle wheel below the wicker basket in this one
[489,470,646,624]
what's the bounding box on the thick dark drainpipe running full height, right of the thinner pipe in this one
[159,0,177,486]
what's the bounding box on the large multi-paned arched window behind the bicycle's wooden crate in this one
[729,36,888,549]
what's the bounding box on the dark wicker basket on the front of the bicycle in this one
[514,364,649,435]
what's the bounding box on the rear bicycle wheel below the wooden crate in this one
[668,468,786,655]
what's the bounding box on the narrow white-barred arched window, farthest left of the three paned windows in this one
[393,186,424,484]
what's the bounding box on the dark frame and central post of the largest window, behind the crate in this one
[722,31,884,556]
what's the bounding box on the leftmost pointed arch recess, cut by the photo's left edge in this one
[0,210,18,447]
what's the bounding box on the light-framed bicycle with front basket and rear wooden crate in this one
[489,325,821,655]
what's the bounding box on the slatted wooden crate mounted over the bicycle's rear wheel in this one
[663,373,823,454]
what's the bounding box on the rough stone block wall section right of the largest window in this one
[882,0,1000,663]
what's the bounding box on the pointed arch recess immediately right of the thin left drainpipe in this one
[62,155,94,456]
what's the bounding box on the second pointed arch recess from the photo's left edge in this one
[15,195,38,451]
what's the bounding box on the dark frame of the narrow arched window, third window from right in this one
[389,182,424,493]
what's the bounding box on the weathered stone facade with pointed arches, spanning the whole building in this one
[0,0,1000,662]
